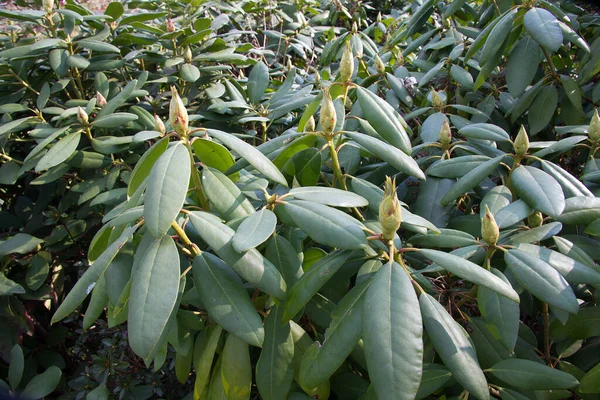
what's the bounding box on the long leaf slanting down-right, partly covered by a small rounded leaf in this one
[188,211,286,299]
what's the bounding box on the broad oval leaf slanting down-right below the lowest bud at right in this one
[504,249,579,314]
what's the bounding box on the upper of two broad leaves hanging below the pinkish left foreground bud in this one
[144,143,191,238]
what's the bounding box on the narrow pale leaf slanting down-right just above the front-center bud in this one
[345,132,425,180]
